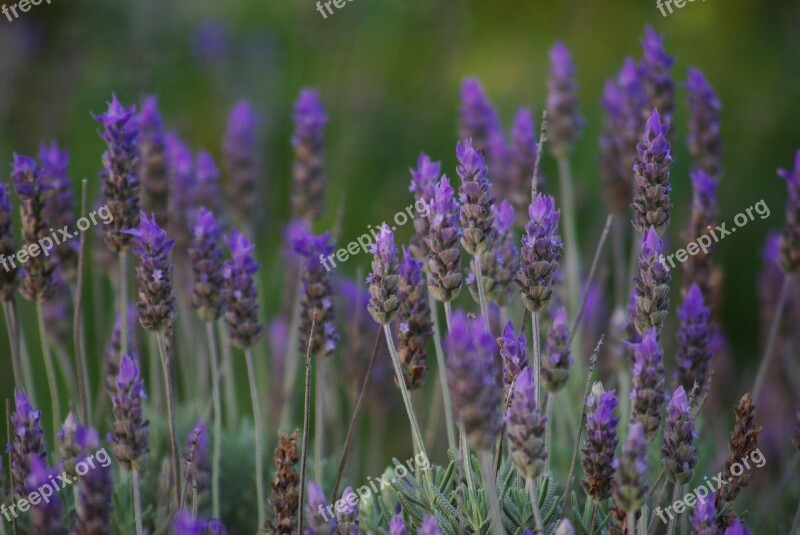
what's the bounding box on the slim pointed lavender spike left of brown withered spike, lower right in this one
[661,386,697,485]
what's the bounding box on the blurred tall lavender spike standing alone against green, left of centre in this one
[292,89,328,221]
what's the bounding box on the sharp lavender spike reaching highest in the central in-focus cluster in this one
[456,139,495,256]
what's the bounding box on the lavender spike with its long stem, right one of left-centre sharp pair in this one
[223,229,266,526]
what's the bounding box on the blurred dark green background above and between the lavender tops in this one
[0,0,800,366]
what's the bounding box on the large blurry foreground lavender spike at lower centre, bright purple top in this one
[445,311,502,451]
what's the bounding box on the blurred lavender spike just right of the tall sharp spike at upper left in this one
[137,97,170,228]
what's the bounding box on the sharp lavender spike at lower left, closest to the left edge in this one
[7,390,47,500]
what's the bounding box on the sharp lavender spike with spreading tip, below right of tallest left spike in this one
[128,212,175,332]
